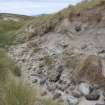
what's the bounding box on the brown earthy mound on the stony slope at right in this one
[73,55,105,86]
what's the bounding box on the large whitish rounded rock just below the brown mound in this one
[79,83,91,96]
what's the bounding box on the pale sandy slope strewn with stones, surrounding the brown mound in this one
[9,19,105,105]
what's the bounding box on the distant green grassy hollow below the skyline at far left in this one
[0,14,31,48]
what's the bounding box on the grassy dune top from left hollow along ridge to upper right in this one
[0,0,105,47]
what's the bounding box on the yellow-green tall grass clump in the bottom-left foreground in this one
[2,80,36,105]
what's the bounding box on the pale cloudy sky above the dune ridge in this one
[0,0,81,15]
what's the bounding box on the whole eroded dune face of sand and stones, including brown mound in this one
[9,3,105,105]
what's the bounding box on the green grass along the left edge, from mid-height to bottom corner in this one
[0,49,36,105]
